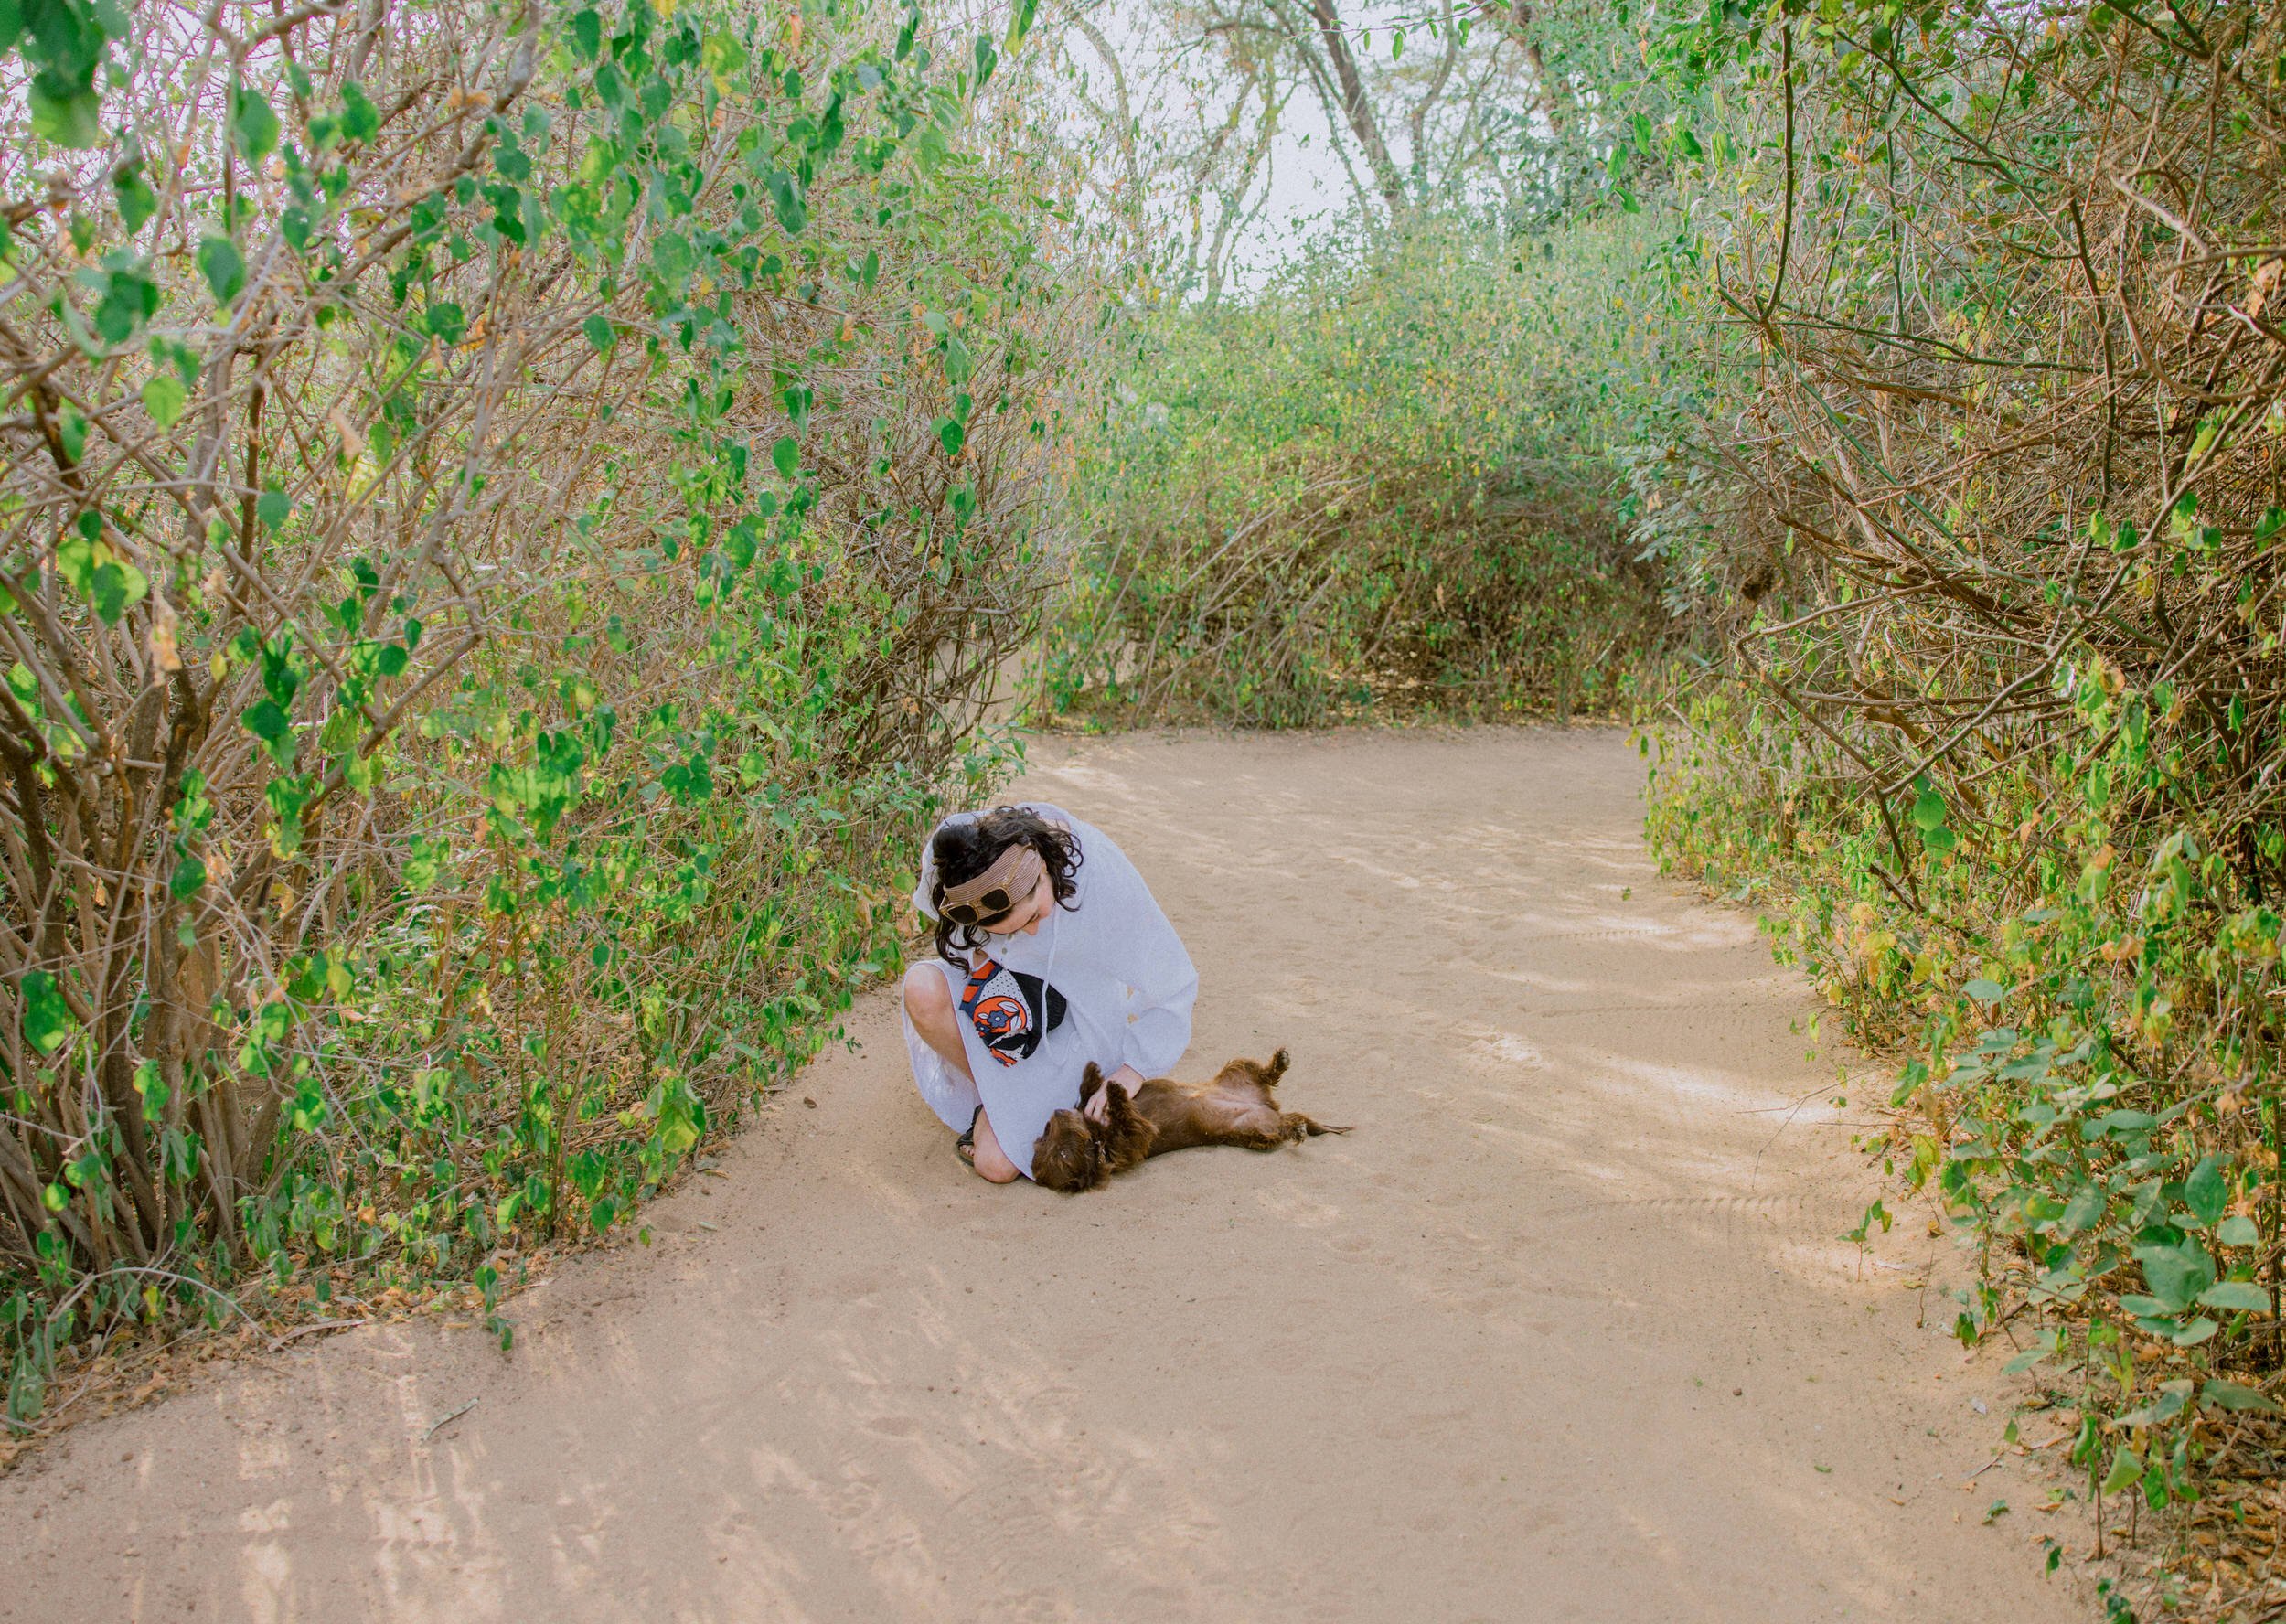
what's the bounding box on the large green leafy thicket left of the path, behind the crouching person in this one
[0,0,1088,1427]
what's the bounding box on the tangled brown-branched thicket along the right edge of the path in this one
[1646,0,2286,1597]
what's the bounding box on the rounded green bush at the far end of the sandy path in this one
[1045,215,1664,725]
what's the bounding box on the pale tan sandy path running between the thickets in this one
[0,732,2089,1624]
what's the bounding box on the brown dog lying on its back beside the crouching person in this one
[1031,1050,1349,1196]
